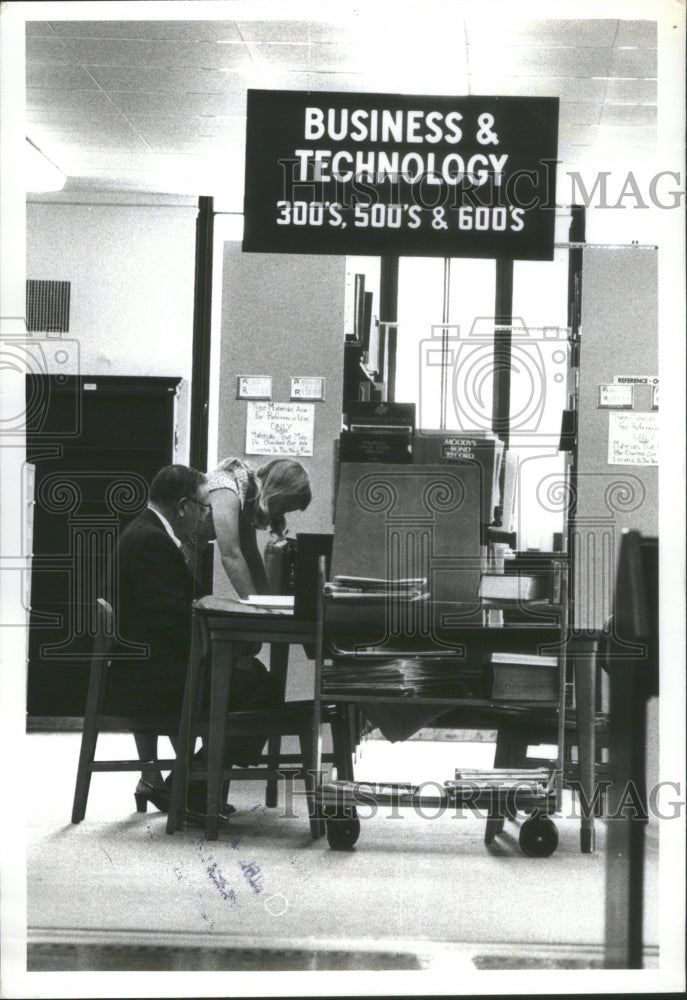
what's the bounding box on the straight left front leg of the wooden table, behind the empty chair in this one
[205,638,234,840]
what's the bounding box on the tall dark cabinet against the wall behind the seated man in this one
[26,375,181,716]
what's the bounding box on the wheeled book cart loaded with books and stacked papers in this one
[313,559,567,857]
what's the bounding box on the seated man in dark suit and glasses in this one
[108,465,280,820]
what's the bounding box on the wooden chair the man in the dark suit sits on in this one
[72,598,179,823]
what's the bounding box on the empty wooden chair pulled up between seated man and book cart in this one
[167,615,352,840]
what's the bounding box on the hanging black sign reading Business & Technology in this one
[243,90,559,260]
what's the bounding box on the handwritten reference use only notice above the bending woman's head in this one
[246,402,315,456]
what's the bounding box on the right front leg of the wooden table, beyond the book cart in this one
[568,639,597,854]
